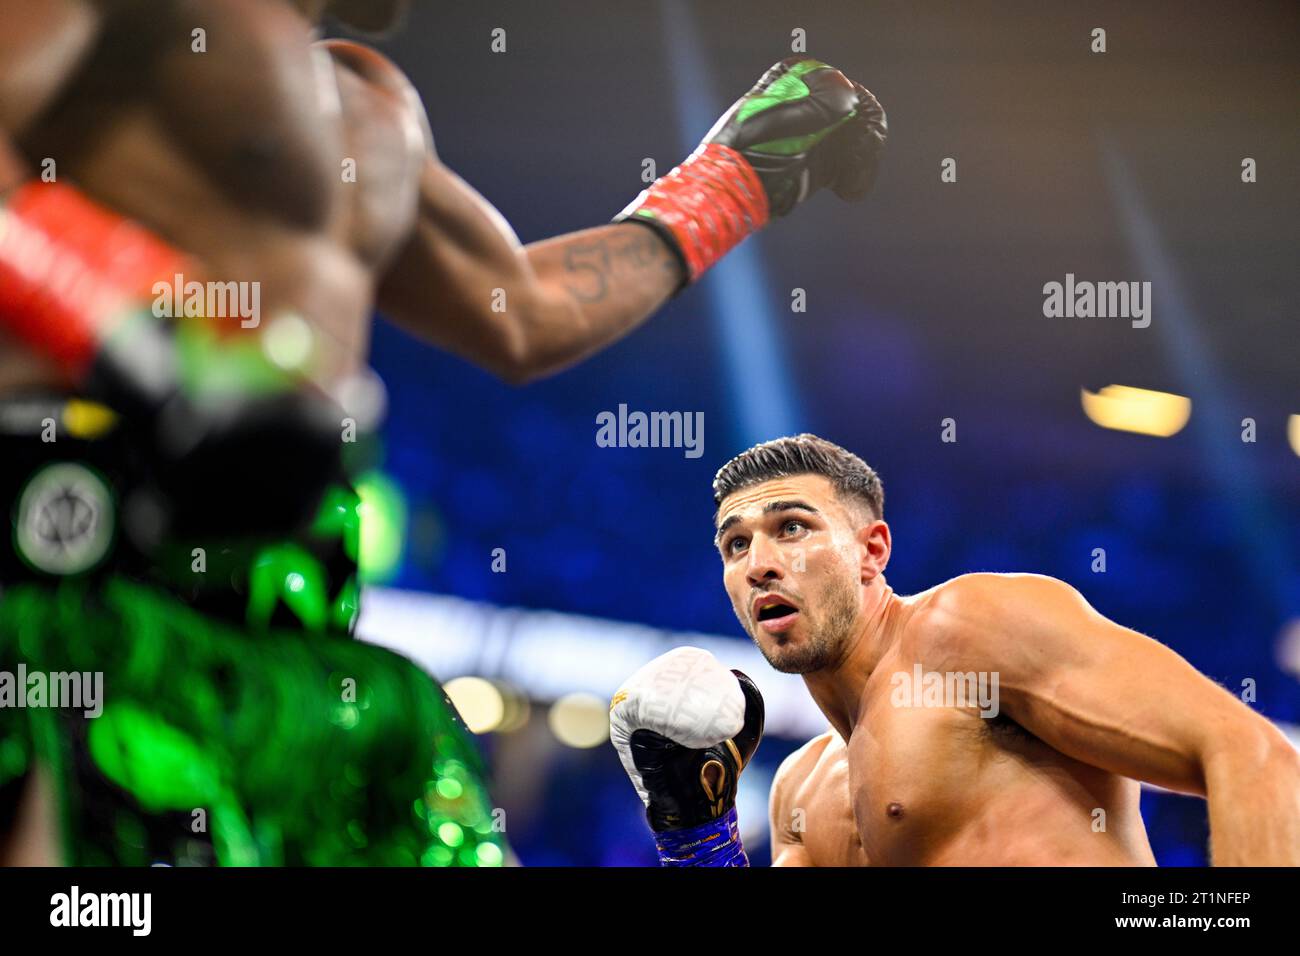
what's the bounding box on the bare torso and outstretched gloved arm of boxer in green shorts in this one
[0,0,885,389]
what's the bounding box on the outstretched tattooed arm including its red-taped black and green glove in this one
[366,49,885,382]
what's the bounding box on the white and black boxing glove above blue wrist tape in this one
[610,648,763,832]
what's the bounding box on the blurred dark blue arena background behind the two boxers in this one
[327,0,1300,865]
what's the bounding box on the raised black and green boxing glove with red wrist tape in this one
[615,56,888,282]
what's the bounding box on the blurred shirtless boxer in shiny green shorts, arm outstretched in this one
[0,0,884,865]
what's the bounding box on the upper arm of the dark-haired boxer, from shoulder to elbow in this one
[941,575,1261,793]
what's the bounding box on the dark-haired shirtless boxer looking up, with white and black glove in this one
[614,434,1300,866]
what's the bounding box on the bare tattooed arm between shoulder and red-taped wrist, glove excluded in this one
[380,156,683,384]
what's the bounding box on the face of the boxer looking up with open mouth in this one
[718,475,871,674]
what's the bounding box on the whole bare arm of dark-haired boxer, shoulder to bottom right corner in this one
[926,575,1300,866]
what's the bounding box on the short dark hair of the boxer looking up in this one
[714,432,885,518]
